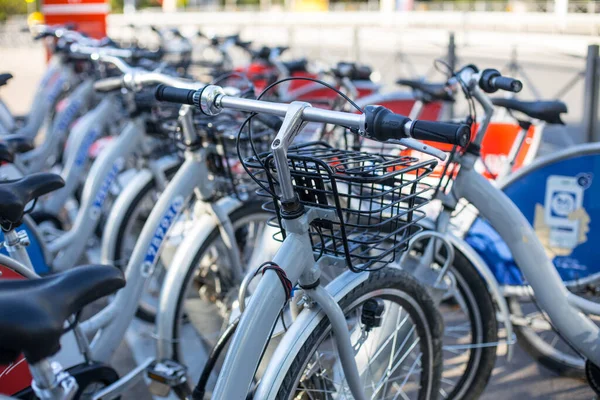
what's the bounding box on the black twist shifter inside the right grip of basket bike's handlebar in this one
[364,106,410,142]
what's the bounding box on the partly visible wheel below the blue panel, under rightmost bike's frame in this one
[508,297,600,379]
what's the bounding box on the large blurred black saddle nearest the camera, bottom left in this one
[0,265,125,364]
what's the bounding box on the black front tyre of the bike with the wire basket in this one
[276,267,443,400]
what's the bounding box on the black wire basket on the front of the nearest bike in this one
[246,142,436,272]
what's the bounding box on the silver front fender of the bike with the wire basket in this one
[254,270,369,400]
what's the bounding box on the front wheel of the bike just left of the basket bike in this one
[172,199,273,386]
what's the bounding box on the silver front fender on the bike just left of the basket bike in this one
[156,197,243,359]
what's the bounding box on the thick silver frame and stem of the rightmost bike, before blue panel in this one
[437,69,600,365]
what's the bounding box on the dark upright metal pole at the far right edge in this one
[583,44,600,142]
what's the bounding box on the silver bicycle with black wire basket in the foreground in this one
[152,86,468,399]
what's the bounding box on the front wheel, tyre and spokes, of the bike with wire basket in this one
[277,267,443,400]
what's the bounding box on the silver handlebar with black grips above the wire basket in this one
[155,85,470,146]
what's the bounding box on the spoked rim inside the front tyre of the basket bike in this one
[289,289,432,400]
